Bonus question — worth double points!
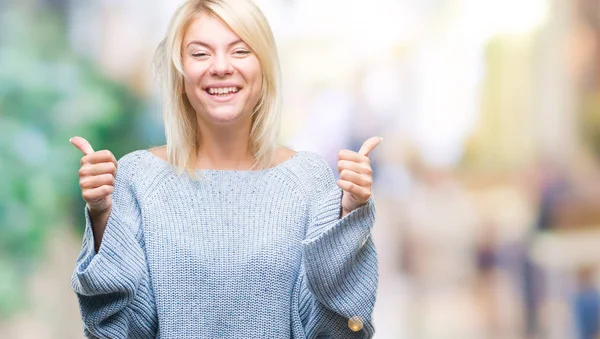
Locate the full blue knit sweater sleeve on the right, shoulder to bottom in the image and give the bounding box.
[296,158,378,338]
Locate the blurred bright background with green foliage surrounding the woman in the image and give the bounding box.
[0,0,600,339]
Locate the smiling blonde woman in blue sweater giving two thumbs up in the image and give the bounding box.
[70,0,381,338]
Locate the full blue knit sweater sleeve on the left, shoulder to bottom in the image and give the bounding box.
[71,155,158,338]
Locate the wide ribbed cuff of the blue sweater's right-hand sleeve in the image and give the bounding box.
[302,190,378,337]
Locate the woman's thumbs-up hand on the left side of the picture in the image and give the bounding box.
[69,137,117,213]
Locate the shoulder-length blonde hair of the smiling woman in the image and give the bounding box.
[154,0,281,177]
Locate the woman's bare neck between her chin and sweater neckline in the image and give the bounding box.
[198,119,254,170]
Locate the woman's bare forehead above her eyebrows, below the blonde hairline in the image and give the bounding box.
[183,13,240,45]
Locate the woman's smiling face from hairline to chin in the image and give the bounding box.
[182,14,262,125]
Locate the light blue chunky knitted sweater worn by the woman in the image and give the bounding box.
[71,150,378,339]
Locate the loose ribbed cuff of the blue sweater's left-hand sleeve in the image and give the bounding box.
[72,206,145,295]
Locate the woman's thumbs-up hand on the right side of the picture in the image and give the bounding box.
[337,137,382,217]
